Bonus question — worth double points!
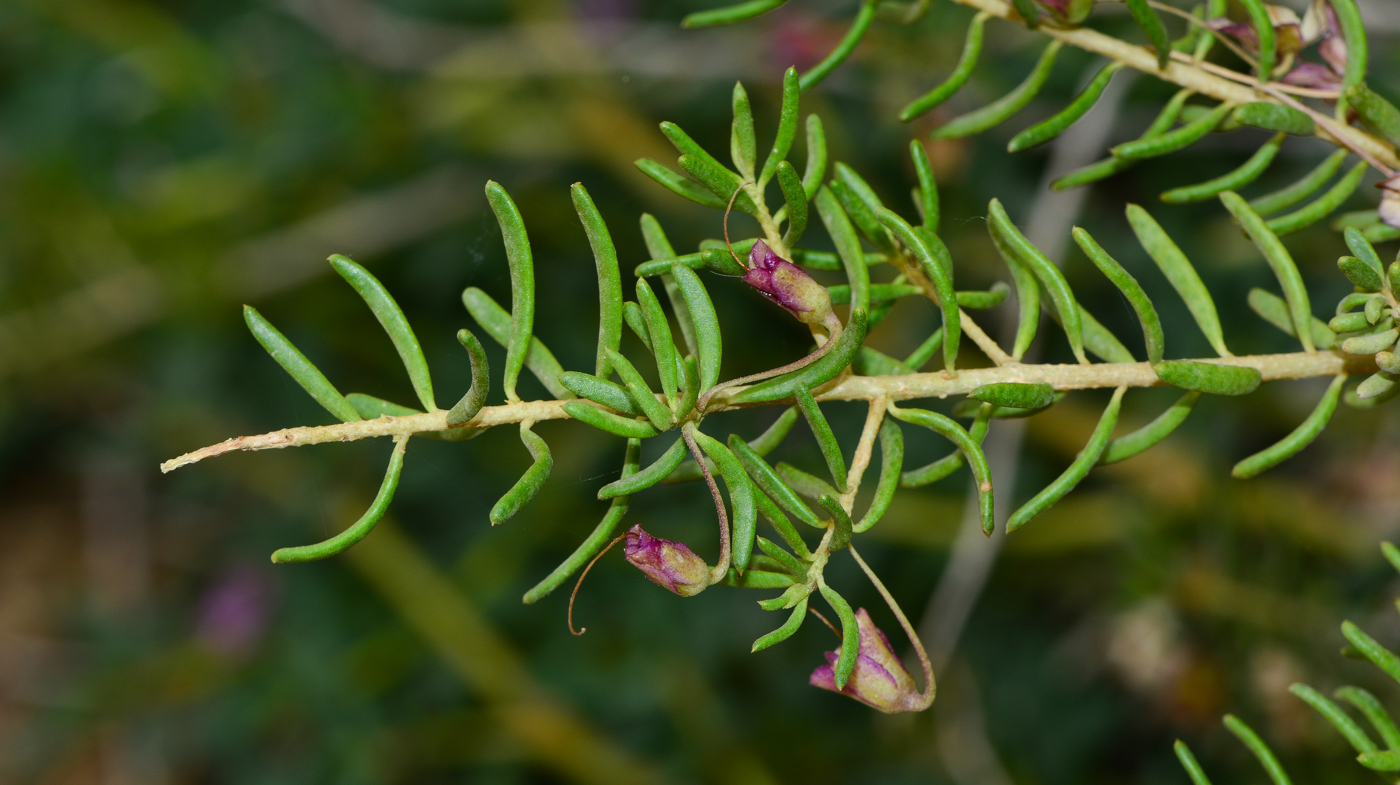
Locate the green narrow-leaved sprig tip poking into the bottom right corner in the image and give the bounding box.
[1176,543,1400,785]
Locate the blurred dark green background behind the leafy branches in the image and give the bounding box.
[8,0,1400,785]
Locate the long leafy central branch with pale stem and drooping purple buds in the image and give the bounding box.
[162,79,1400,711]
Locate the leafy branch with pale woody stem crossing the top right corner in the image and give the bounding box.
[687,0,1400,242]
